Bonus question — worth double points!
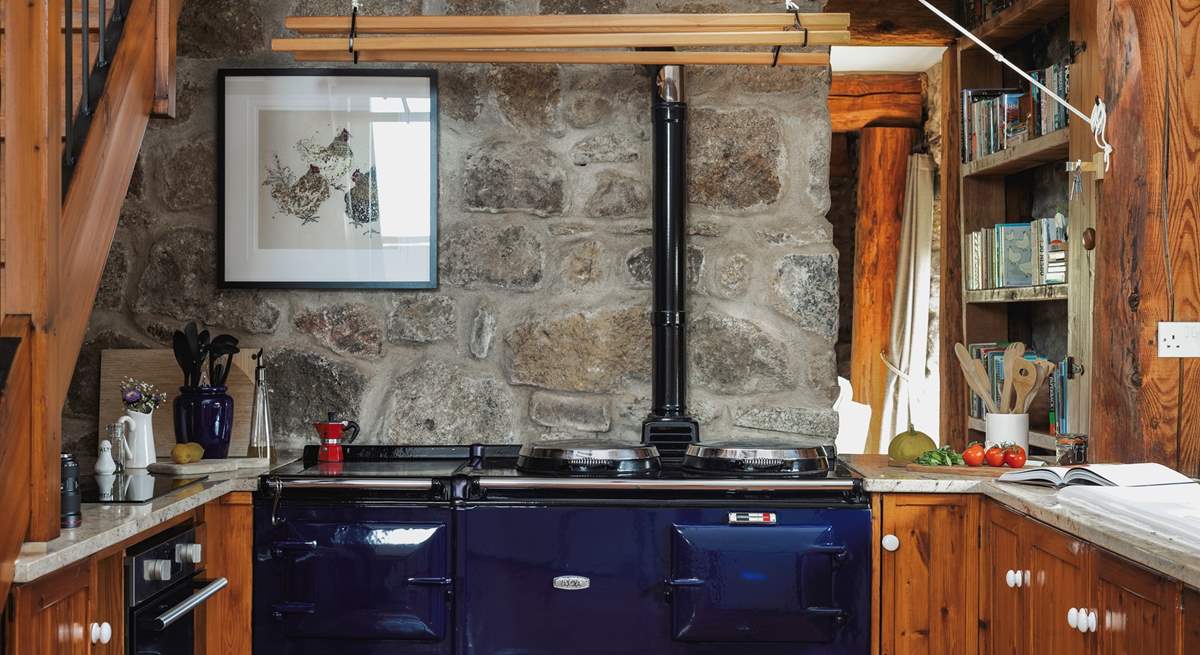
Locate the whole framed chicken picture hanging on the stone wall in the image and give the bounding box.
[217,68,438,289]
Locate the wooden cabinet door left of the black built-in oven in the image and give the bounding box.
[7,560,92,655]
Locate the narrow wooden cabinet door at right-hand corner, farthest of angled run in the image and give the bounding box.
[979,500,1028,655]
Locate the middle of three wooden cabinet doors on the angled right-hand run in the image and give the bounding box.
[1019,519,1092,655]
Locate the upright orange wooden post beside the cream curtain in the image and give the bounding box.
[851,127,917,452]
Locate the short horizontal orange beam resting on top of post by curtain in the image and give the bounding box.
[829,73,925,132]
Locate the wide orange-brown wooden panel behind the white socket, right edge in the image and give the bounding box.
[1091,0,1200,474]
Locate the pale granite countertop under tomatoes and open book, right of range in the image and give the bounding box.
[842,455,1200,589]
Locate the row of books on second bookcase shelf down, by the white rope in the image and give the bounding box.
[961,64,1070,163]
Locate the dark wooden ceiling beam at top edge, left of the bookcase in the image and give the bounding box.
[826,0,958,46]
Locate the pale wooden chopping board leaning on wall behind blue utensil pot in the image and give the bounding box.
[97,348,258,457]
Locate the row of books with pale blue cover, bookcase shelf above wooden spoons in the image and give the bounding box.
[966,214,1067,290]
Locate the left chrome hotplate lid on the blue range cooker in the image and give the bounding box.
[517,439,662,476]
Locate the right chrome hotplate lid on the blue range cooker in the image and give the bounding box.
[683,439,835,475]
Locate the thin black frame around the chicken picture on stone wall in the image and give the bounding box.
[216,68,440,290]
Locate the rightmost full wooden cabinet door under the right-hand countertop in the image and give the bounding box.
[1093,552,1180,655]
